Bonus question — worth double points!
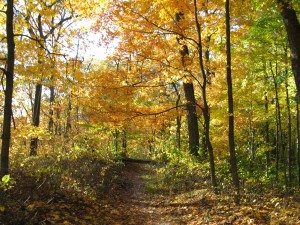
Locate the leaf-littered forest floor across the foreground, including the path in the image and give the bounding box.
[0,159,300,225]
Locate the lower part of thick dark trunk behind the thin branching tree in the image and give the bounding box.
[183,83,200,156]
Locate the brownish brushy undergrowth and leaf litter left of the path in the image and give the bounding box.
[0,150,122,225]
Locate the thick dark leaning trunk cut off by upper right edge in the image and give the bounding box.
[276,0,300,97]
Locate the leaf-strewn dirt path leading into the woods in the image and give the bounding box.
[101,162,199,225]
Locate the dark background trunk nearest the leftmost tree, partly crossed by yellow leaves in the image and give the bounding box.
[30,84,42,156]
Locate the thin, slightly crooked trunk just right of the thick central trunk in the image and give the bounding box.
[194,0,217,190]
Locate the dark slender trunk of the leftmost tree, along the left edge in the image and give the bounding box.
[0,0,15,177]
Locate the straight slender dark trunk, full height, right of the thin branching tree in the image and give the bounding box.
[225,0,240,203]
